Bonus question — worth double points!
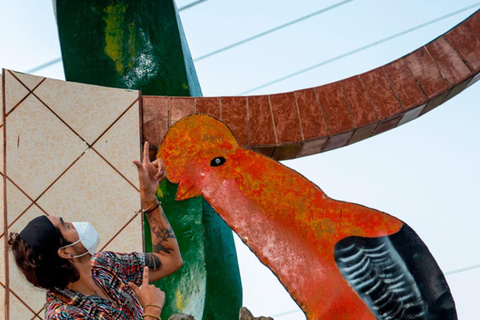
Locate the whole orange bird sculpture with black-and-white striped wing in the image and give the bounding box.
[158,115,456,320]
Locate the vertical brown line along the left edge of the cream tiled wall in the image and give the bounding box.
[2,69,10,320]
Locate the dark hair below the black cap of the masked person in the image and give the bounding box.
[8,230,80,290]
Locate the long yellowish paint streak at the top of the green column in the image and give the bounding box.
[103,3,126,75]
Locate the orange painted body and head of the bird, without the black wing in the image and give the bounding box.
[158,115,403,320]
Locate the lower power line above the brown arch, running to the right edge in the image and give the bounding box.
[239,2,480,95]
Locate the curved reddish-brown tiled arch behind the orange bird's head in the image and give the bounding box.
[143,10,480,160]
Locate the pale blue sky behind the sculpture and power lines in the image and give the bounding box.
[0,0,480,320]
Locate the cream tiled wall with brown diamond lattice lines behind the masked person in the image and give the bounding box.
[0,70,143,320]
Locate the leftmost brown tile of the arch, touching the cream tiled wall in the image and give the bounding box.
[142,96,168,146]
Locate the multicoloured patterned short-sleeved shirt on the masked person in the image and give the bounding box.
[45,251,145,320]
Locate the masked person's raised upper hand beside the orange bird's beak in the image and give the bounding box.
[133,142,167,202]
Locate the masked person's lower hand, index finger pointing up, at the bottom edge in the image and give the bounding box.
[128,267,165,315]
